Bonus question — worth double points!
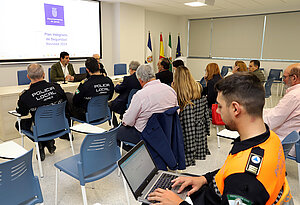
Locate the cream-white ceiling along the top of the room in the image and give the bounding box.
[102,0,300,18]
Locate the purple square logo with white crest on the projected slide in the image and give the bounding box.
[44,4,65,26]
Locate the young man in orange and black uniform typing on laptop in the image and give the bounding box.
[148,72,292,205]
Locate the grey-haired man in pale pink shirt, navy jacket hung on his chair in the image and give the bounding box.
[117,65,178,149]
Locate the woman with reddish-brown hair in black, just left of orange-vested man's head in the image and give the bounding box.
[204,63,222,109]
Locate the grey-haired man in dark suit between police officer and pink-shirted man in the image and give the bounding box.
[109,61,142,126]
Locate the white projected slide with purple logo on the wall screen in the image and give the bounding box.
[0,0,101,60]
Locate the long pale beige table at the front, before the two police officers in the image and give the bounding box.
[0,75,124,141]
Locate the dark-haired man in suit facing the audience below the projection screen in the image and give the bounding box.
[50,51,75,82]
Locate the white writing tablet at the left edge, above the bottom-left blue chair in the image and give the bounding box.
[0,141,27,162]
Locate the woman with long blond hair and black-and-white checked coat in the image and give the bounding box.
[172,66,210,167]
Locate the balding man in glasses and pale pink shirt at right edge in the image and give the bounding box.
[263,63,300,156]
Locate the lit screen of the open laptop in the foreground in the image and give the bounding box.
[119,144,156,192]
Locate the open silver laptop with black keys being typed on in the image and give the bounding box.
[118,141,188,204]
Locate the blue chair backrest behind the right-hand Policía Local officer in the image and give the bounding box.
[86,95,111,124]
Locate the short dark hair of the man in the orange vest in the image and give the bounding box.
[215,72,265,117]
